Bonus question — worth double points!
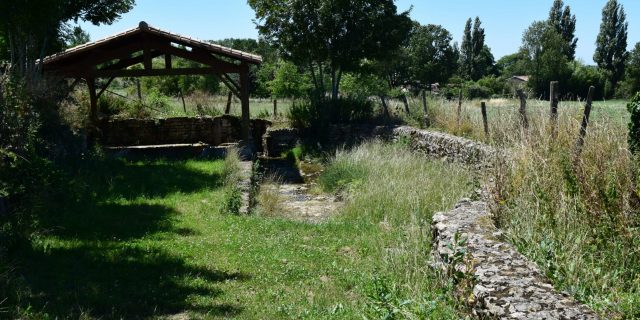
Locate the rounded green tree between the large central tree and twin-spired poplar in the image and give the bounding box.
[406,23,457,85]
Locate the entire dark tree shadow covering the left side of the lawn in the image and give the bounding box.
[0,160,249,319]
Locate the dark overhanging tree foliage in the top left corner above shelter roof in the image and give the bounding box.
[0,0,134,76]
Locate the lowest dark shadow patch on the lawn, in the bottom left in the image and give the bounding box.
[19,244,248,319]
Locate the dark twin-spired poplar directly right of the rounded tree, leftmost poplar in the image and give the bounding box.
[459,17,494,81]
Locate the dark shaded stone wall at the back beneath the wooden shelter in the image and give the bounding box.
[99,115,271,151]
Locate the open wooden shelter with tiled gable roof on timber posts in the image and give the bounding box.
[43,21,262,141]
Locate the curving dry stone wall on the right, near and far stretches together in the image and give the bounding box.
[393,127,598,319]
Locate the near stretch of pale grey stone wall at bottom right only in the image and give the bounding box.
[432,200,598,319]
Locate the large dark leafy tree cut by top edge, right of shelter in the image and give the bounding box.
[249,0,411,100]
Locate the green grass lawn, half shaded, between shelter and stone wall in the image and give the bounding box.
[7,143,470,319]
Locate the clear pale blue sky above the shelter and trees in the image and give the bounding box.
[82,0,640,64]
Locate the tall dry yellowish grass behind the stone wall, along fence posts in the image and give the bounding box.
[402,96,640,319]
